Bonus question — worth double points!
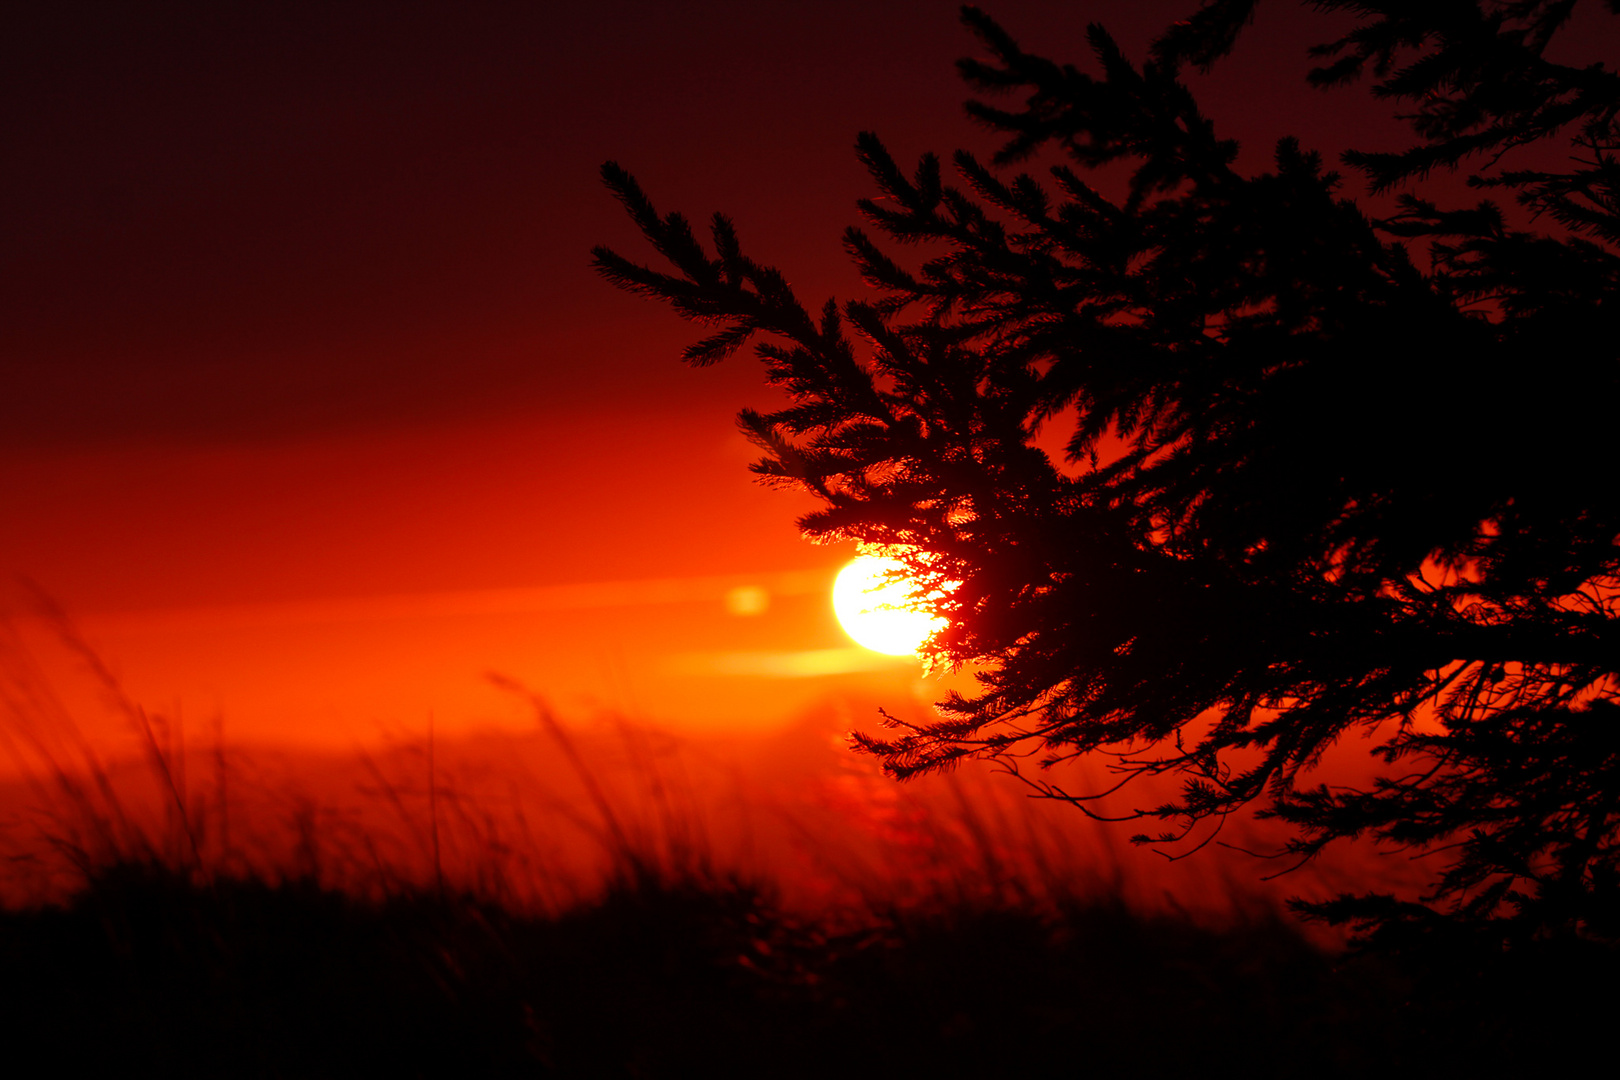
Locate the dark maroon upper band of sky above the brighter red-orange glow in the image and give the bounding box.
[0,2,1023,445]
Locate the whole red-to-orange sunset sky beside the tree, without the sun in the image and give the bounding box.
[9,0,1607,751]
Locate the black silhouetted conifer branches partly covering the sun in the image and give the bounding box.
[596,0,1620,939]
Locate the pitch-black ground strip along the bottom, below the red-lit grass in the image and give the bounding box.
[0,865,1620,1077]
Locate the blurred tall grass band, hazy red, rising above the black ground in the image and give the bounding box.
[0,602,1321,923]
